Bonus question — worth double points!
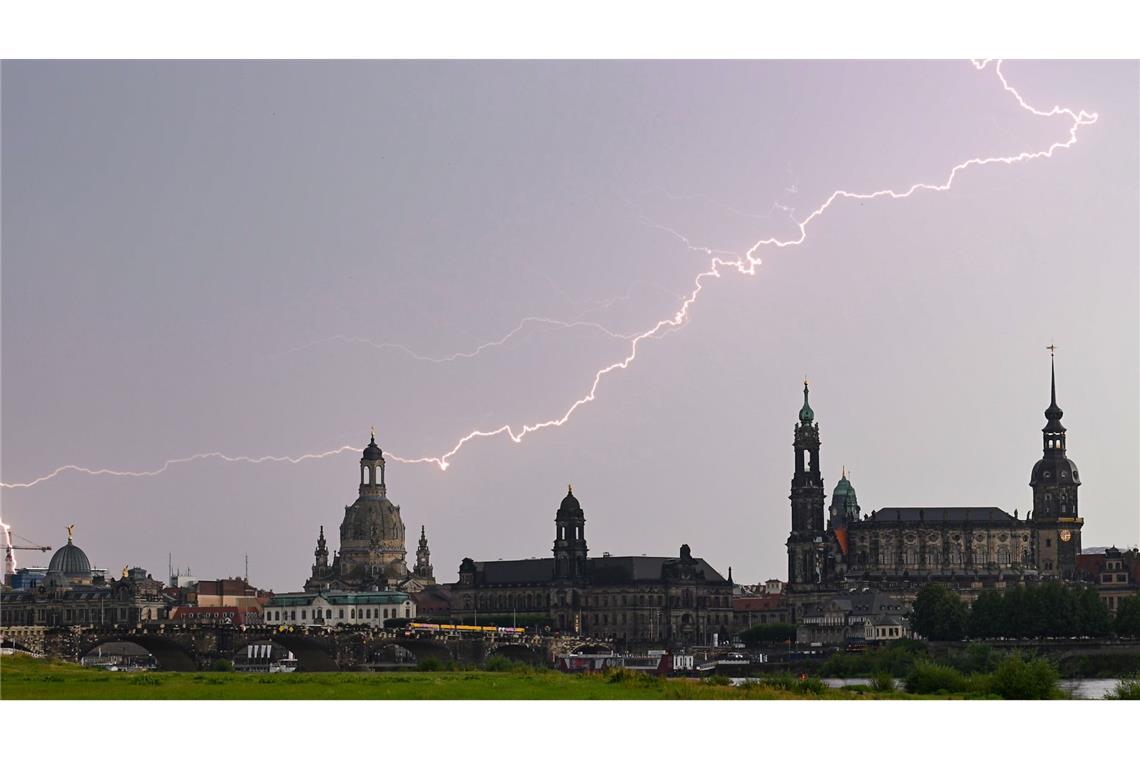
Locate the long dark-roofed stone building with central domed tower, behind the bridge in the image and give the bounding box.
[451,489,733,647]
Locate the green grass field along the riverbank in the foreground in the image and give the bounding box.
[0,655,909,700]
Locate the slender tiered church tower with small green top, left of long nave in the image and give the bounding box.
[788,379,824,591]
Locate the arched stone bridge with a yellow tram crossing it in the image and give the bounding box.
[0,623,601,672]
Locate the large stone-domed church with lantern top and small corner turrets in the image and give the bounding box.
[304,433,435,593]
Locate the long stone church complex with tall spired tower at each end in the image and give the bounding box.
[787,359,1084,594]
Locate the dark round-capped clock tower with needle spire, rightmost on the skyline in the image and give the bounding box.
[1029,346,1084,579]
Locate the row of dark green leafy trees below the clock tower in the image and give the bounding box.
[911,581,1140,641]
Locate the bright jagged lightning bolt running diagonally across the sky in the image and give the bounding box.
[0,59,1098,488]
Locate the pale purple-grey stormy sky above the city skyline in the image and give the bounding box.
[0,60,1140,591]
